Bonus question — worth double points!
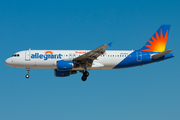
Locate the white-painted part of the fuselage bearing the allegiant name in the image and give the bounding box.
[5,50,133,70]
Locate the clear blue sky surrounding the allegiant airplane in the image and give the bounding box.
[0,0,180,120]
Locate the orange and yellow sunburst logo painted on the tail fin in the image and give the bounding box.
[142,29,168,52]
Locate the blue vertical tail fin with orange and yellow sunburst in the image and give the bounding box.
[140,25,170,52]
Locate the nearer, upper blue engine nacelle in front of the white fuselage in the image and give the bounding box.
[57,60,73,71]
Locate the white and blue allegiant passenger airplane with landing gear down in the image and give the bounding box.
[5,25,174,81]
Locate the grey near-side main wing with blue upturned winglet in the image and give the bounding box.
[73,42,112,67]
